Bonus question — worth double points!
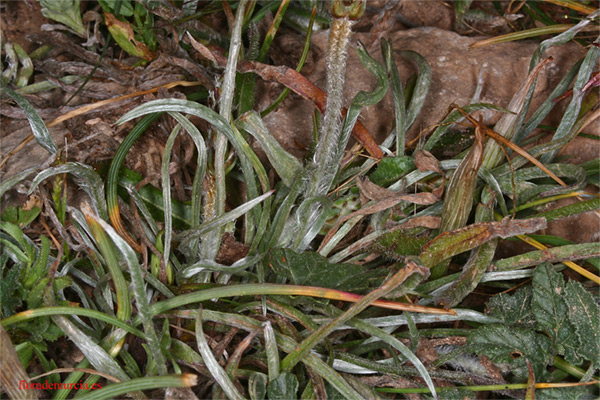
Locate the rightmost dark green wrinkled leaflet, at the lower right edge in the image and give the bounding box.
[565,281,600,368]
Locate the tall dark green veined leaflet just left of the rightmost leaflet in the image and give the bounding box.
[532,264,583,365]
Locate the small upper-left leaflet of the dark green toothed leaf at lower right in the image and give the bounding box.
[487,286,536,329]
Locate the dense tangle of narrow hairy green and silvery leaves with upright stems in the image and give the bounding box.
[0,1,600,399]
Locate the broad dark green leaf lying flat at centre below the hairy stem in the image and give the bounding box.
[269,249,387,292]
